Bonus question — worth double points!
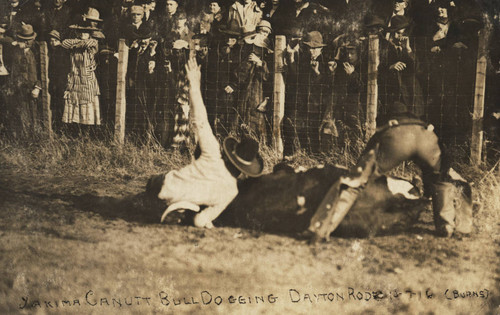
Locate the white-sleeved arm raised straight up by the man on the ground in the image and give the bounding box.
[186,58,220,156]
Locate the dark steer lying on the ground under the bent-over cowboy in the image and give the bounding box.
[217,166,425,236]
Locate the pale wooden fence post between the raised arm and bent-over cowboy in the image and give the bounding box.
[273,35,286,157]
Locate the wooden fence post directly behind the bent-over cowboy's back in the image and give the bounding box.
[366,35,380,140]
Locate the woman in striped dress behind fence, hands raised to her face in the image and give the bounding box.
[62,25,101,125]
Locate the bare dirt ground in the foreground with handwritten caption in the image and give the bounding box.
[0,166,500,314]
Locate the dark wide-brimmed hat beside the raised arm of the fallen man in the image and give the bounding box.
[223,137,264,177]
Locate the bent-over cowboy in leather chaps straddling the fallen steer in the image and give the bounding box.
[308,102,472,241]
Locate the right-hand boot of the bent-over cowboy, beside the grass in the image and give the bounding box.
[432,182,455,237]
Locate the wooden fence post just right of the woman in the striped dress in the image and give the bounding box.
[115,39,128,144]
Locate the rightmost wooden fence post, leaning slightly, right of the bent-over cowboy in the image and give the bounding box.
[470,30,487,165]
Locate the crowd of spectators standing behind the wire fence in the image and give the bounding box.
[0,0,492,154]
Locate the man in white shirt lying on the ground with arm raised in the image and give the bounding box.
[146,58,264,228]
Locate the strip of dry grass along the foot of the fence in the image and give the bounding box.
[0,130,500,223]
